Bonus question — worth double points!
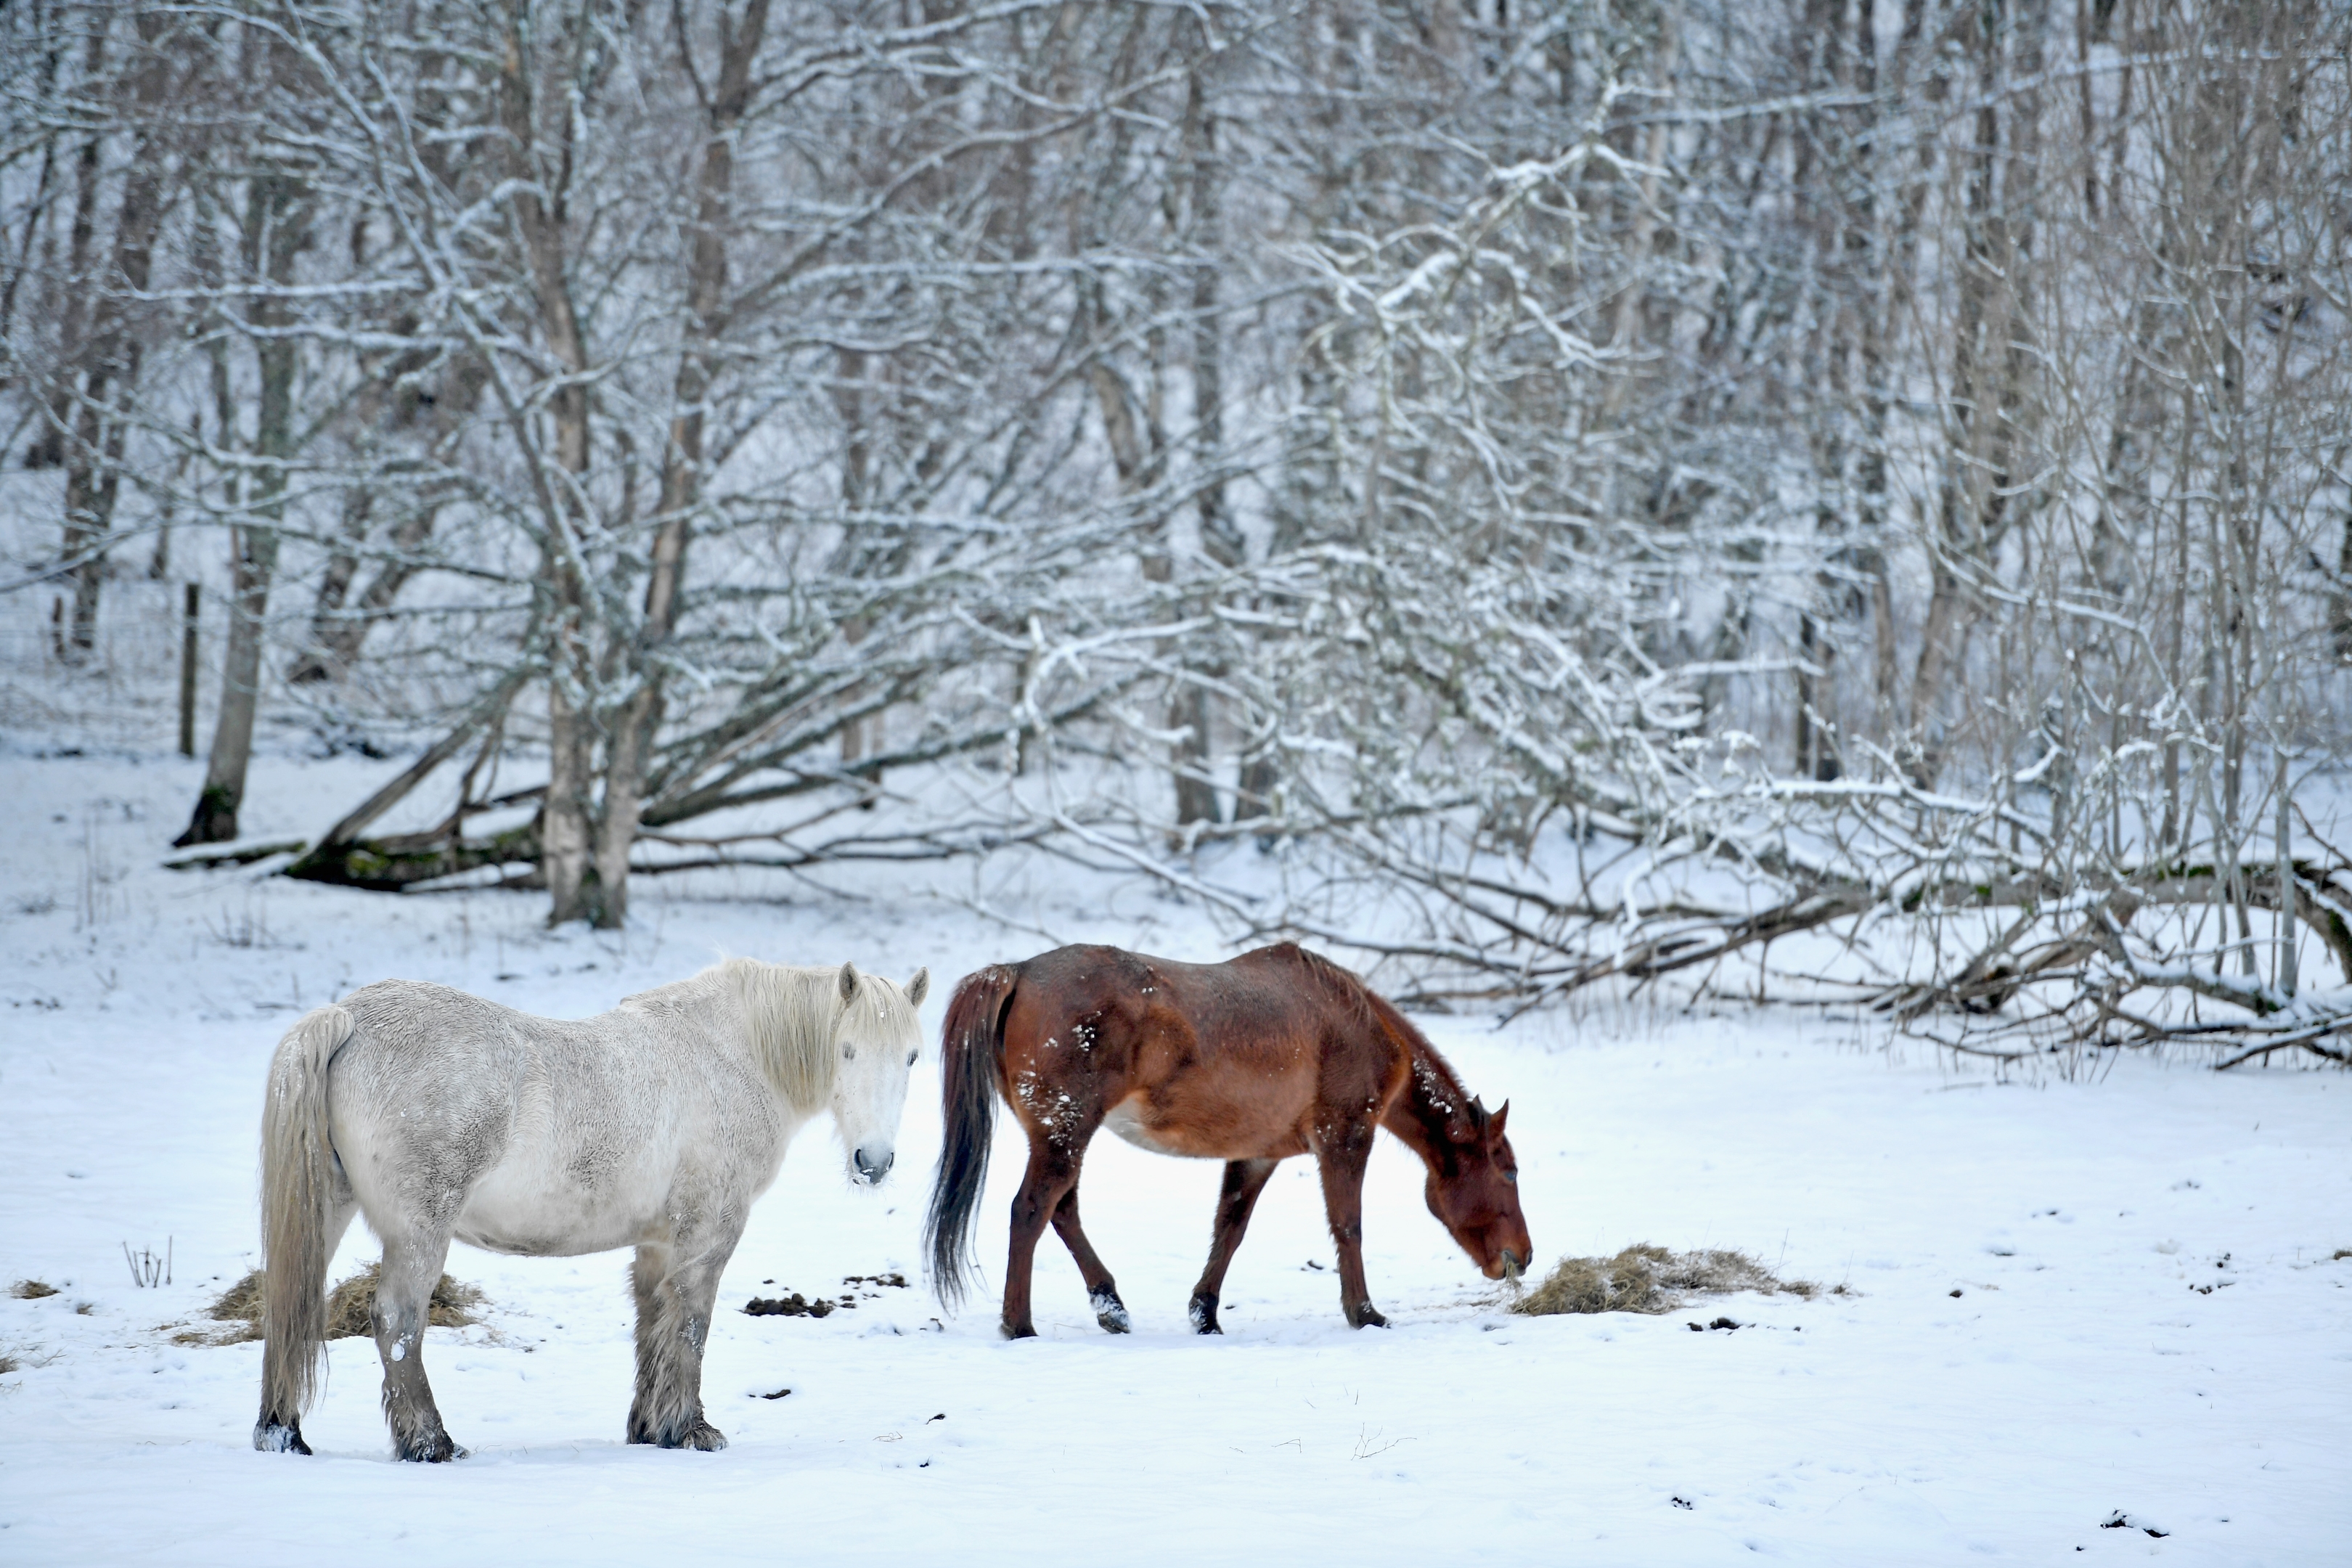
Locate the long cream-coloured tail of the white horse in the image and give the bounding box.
[254,1006,357,1448]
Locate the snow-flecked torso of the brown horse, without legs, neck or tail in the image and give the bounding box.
[1000,945,1409,1159]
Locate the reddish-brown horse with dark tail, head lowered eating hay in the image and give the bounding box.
[924,943,1533,1340]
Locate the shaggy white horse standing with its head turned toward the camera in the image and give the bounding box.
[254,959,931,1460]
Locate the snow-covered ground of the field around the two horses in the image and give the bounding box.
[0,747,2352,1568]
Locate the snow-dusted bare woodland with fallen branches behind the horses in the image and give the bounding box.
[0,0,2352,1063]
